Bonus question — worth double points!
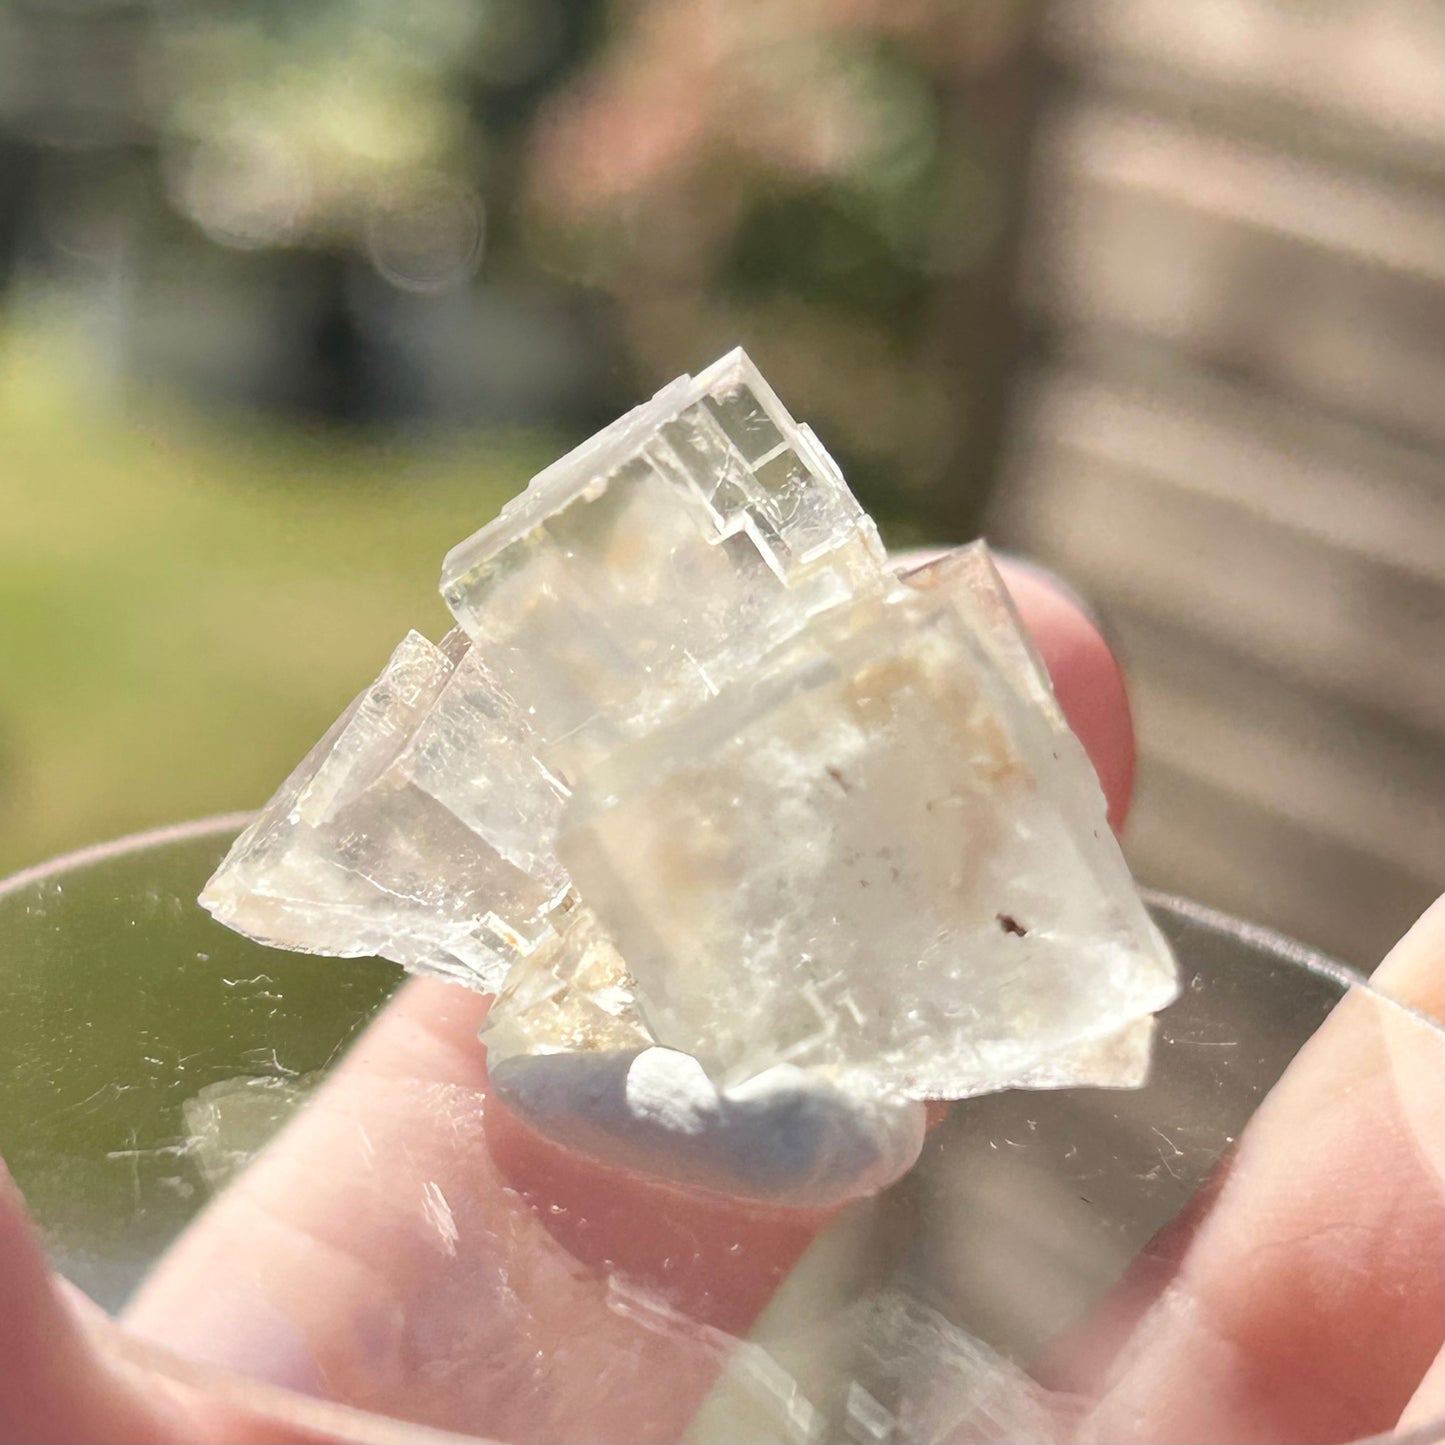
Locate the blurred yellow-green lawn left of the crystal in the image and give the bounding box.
[0,322,562,876]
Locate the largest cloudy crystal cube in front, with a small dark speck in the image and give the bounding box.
[559,555,1175,1098]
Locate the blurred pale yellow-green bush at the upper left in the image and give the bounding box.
[159,0,531,275]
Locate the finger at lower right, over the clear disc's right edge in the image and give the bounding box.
[1051,903,1445,1441]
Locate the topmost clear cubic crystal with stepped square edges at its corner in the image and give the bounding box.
[442,351,887,785]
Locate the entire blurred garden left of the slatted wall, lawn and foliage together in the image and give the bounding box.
[0,0,1033,870]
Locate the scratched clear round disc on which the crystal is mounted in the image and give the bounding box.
[0,816,1442,1442]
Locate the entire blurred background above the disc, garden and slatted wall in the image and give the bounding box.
[0,0,1445,964]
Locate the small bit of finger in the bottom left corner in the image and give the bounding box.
[0,1165,195,1445]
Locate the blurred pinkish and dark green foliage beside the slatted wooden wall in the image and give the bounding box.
[529,0,1035,533]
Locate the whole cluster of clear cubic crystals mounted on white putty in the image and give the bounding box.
[202,351,1176,1117]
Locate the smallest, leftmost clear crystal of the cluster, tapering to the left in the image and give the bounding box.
[201,633,568,987]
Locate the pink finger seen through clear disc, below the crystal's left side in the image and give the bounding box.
[126,981,824,1439]
